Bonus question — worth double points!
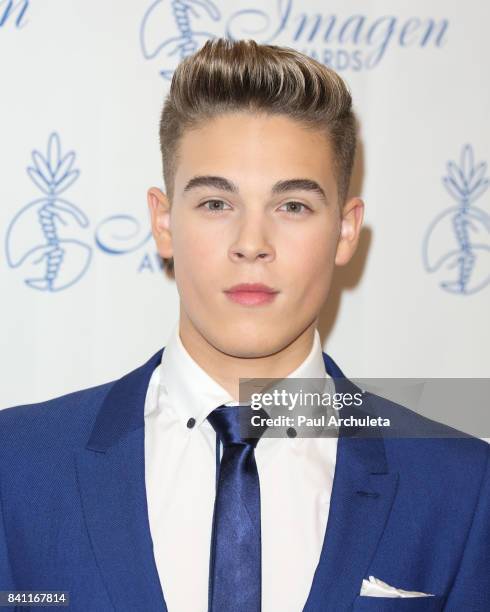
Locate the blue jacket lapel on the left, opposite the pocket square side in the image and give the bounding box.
[75,349,167,612]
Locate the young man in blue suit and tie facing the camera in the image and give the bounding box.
[0,39,490,612]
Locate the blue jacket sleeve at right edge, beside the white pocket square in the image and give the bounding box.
[444,444,490,612]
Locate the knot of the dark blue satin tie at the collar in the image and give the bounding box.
[208,405,268,448]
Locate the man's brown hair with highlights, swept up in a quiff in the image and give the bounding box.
[160,38,356,270]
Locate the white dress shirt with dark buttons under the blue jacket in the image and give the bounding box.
[145,323,337,612]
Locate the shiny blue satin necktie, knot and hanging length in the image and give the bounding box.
[208,406,266,612]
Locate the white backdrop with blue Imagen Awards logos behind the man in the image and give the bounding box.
[0,0,490,408]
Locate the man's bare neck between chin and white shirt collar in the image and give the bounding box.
[179,308,318,402]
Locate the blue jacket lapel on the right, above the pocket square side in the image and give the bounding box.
[304,353,398,612]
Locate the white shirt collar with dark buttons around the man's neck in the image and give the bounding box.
[154,322,330,426]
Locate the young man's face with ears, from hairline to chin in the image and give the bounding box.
[149,113,362,358]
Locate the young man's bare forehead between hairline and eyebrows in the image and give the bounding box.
[175,112,335,193]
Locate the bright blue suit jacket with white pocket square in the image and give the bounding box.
[0,349,490,612]
